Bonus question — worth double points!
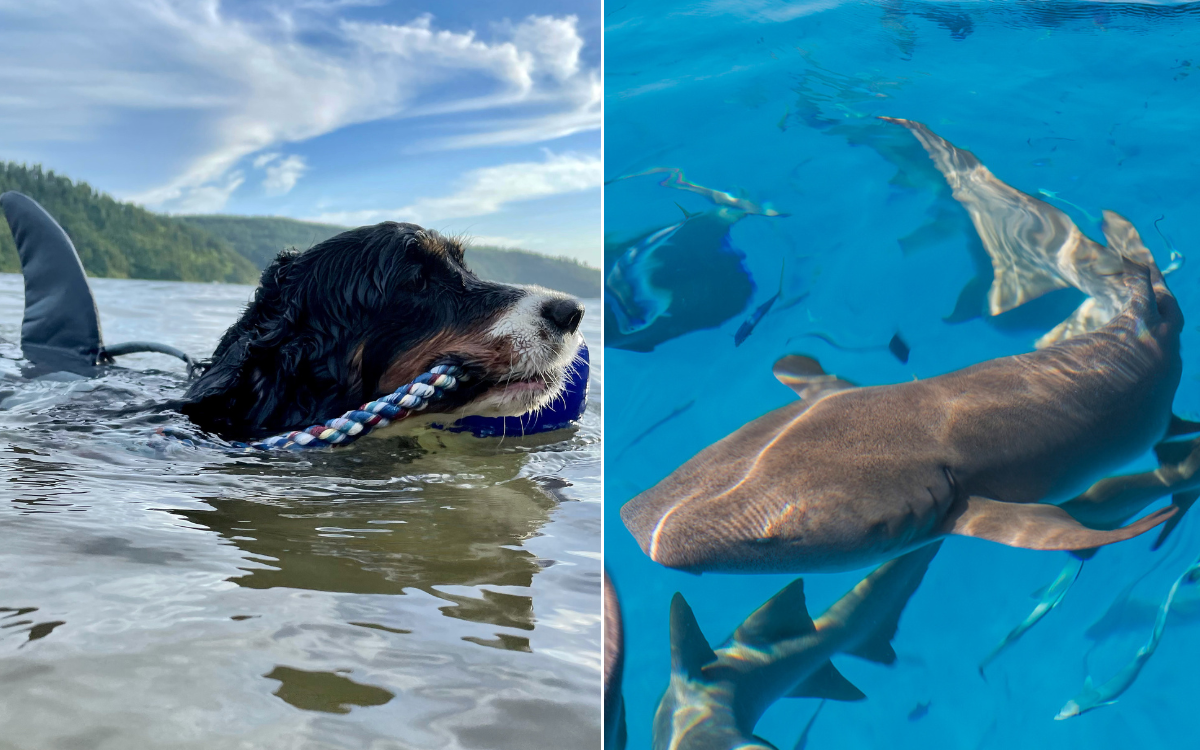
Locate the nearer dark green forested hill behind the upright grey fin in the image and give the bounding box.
[0,162,258,283]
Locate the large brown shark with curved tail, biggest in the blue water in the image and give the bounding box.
[620,118,1200,572]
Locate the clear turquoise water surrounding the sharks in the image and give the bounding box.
[605,0,1200,749]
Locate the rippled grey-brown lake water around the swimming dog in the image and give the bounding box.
[0,275,601,749]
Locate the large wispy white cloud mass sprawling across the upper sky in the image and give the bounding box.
[0,0,600,211]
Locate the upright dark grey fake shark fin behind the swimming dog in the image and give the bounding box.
[0,192,102,374]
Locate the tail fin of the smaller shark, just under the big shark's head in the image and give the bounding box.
[818,541,942,664]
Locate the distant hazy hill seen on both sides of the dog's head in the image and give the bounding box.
[180,216,600,298]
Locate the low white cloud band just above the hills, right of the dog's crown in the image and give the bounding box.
[313,154,602,226]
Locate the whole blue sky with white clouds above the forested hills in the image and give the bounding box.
[0,0,601,265]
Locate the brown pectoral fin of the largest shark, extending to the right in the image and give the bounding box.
[943,496,1177,550]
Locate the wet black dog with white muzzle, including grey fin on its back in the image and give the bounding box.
[0,193,583,438]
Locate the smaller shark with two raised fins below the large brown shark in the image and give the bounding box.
[652,544,940,750]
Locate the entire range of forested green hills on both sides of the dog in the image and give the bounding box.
[0,162,600,298]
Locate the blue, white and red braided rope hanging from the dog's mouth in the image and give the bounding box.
[157,365,464,454]
